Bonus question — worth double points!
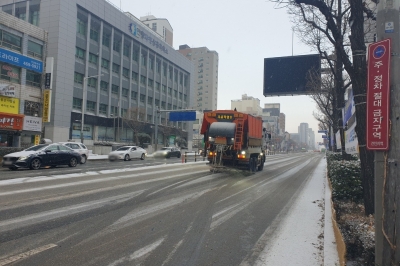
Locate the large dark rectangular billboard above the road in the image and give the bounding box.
[263,54,321,97]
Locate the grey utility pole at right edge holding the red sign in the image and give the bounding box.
[375,0,400,265]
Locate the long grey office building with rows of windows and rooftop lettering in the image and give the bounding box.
[0,0,193,145]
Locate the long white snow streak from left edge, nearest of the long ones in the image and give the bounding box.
[0,190,144,232]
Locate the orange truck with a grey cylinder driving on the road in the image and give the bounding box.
[200,110,267,172]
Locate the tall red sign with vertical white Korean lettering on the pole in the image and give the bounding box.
[367,39,391,151]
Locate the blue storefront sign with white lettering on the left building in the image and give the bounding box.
[0,48,43,73]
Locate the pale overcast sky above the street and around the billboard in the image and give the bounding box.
[109,0,322,145]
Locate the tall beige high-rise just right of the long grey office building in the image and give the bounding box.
[178,44,218,112]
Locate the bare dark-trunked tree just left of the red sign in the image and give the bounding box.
[278,0,374,215]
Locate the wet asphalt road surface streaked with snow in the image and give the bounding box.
[0,153,322,266]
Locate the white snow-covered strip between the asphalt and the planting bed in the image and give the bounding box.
[255,159,339,266]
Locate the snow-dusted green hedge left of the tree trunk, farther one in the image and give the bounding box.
[327,153,363,202]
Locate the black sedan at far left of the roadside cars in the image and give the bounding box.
[2,143,81,170]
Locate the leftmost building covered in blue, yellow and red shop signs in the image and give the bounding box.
[0,9,48,147]
